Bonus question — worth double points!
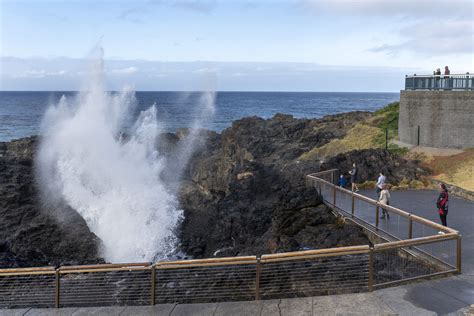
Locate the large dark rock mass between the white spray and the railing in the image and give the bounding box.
[180,112,382,257]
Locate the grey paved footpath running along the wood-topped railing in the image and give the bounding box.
[0,190,474,316]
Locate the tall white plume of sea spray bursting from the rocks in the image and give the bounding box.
[37,48,214,262]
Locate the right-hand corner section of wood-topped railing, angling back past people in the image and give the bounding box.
[307,169,461,288]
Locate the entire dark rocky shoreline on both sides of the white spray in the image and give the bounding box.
[0,112,427,267]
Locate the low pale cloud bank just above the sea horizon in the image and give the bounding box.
[0,57,416,92]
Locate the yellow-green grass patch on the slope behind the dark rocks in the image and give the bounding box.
[299,124,384,160]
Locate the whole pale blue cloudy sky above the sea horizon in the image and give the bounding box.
[0,0,474,92]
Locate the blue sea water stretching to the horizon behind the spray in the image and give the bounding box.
[0,91,400,141]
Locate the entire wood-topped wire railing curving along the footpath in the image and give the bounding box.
[0,170,461,308]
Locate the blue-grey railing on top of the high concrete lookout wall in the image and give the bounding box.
[405,74,474,90]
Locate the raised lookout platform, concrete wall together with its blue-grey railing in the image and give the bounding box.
[398,74,474,149]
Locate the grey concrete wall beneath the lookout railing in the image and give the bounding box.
[398,90,474,148]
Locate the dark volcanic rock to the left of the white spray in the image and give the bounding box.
[0,137,103,267]
